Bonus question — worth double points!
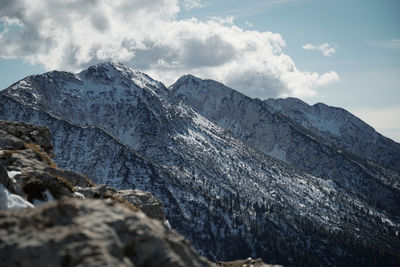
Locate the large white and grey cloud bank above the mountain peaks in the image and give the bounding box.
[0,0,339,98]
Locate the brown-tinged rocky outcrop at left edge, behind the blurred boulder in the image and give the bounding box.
[0,121,88,203]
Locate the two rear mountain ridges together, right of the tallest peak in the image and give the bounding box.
[170,75,400,217]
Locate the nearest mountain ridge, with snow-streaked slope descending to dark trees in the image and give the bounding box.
[0,62,400,265]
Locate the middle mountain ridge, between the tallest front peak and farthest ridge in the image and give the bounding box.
[170,76,400,216]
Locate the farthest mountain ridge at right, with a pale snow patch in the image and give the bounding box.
[264,98,400,172]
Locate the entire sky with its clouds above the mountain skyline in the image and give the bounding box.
[0,0,400,142]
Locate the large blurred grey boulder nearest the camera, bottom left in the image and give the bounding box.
[0,199,213,267]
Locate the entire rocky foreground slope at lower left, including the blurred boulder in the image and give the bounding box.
[0,121,214,266]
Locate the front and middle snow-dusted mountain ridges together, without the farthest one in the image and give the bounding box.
[0,63,400,265]
